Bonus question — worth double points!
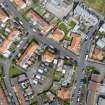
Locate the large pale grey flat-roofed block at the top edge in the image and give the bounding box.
[42,0,73,19]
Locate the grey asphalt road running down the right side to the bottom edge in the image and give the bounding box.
[72,25,99,105]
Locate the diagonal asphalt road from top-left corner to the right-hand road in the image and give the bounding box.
[0,0,78,60]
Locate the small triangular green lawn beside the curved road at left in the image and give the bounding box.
[9,66,24,78]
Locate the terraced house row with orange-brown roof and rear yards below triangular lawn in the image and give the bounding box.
[13,74,34,105]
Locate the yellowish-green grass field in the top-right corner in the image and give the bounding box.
[84,0,105,16]
